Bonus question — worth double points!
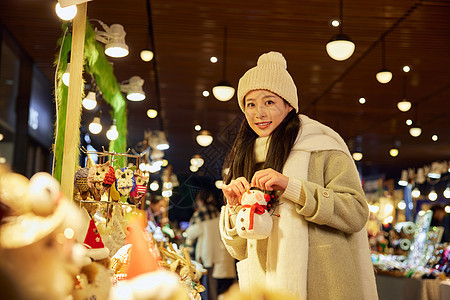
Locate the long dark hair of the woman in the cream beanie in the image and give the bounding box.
[223,109,301,184]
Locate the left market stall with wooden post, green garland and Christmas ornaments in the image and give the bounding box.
[0,1,204,299]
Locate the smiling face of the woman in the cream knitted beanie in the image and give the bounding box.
[244,90,292,137]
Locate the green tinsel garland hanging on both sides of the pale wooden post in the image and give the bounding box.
[53,22,127,181]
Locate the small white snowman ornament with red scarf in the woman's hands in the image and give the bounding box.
[236,190,272,240]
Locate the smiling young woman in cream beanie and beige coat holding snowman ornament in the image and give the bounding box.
[220,52,378,299]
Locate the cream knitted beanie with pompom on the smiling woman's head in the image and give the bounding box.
[237,51,298,112]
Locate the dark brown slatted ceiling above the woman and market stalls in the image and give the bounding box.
[0,0,450,182]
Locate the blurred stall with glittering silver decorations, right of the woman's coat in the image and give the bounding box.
[366,163,450,299]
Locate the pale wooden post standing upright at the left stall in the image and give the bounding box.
[61,2,87,199]
